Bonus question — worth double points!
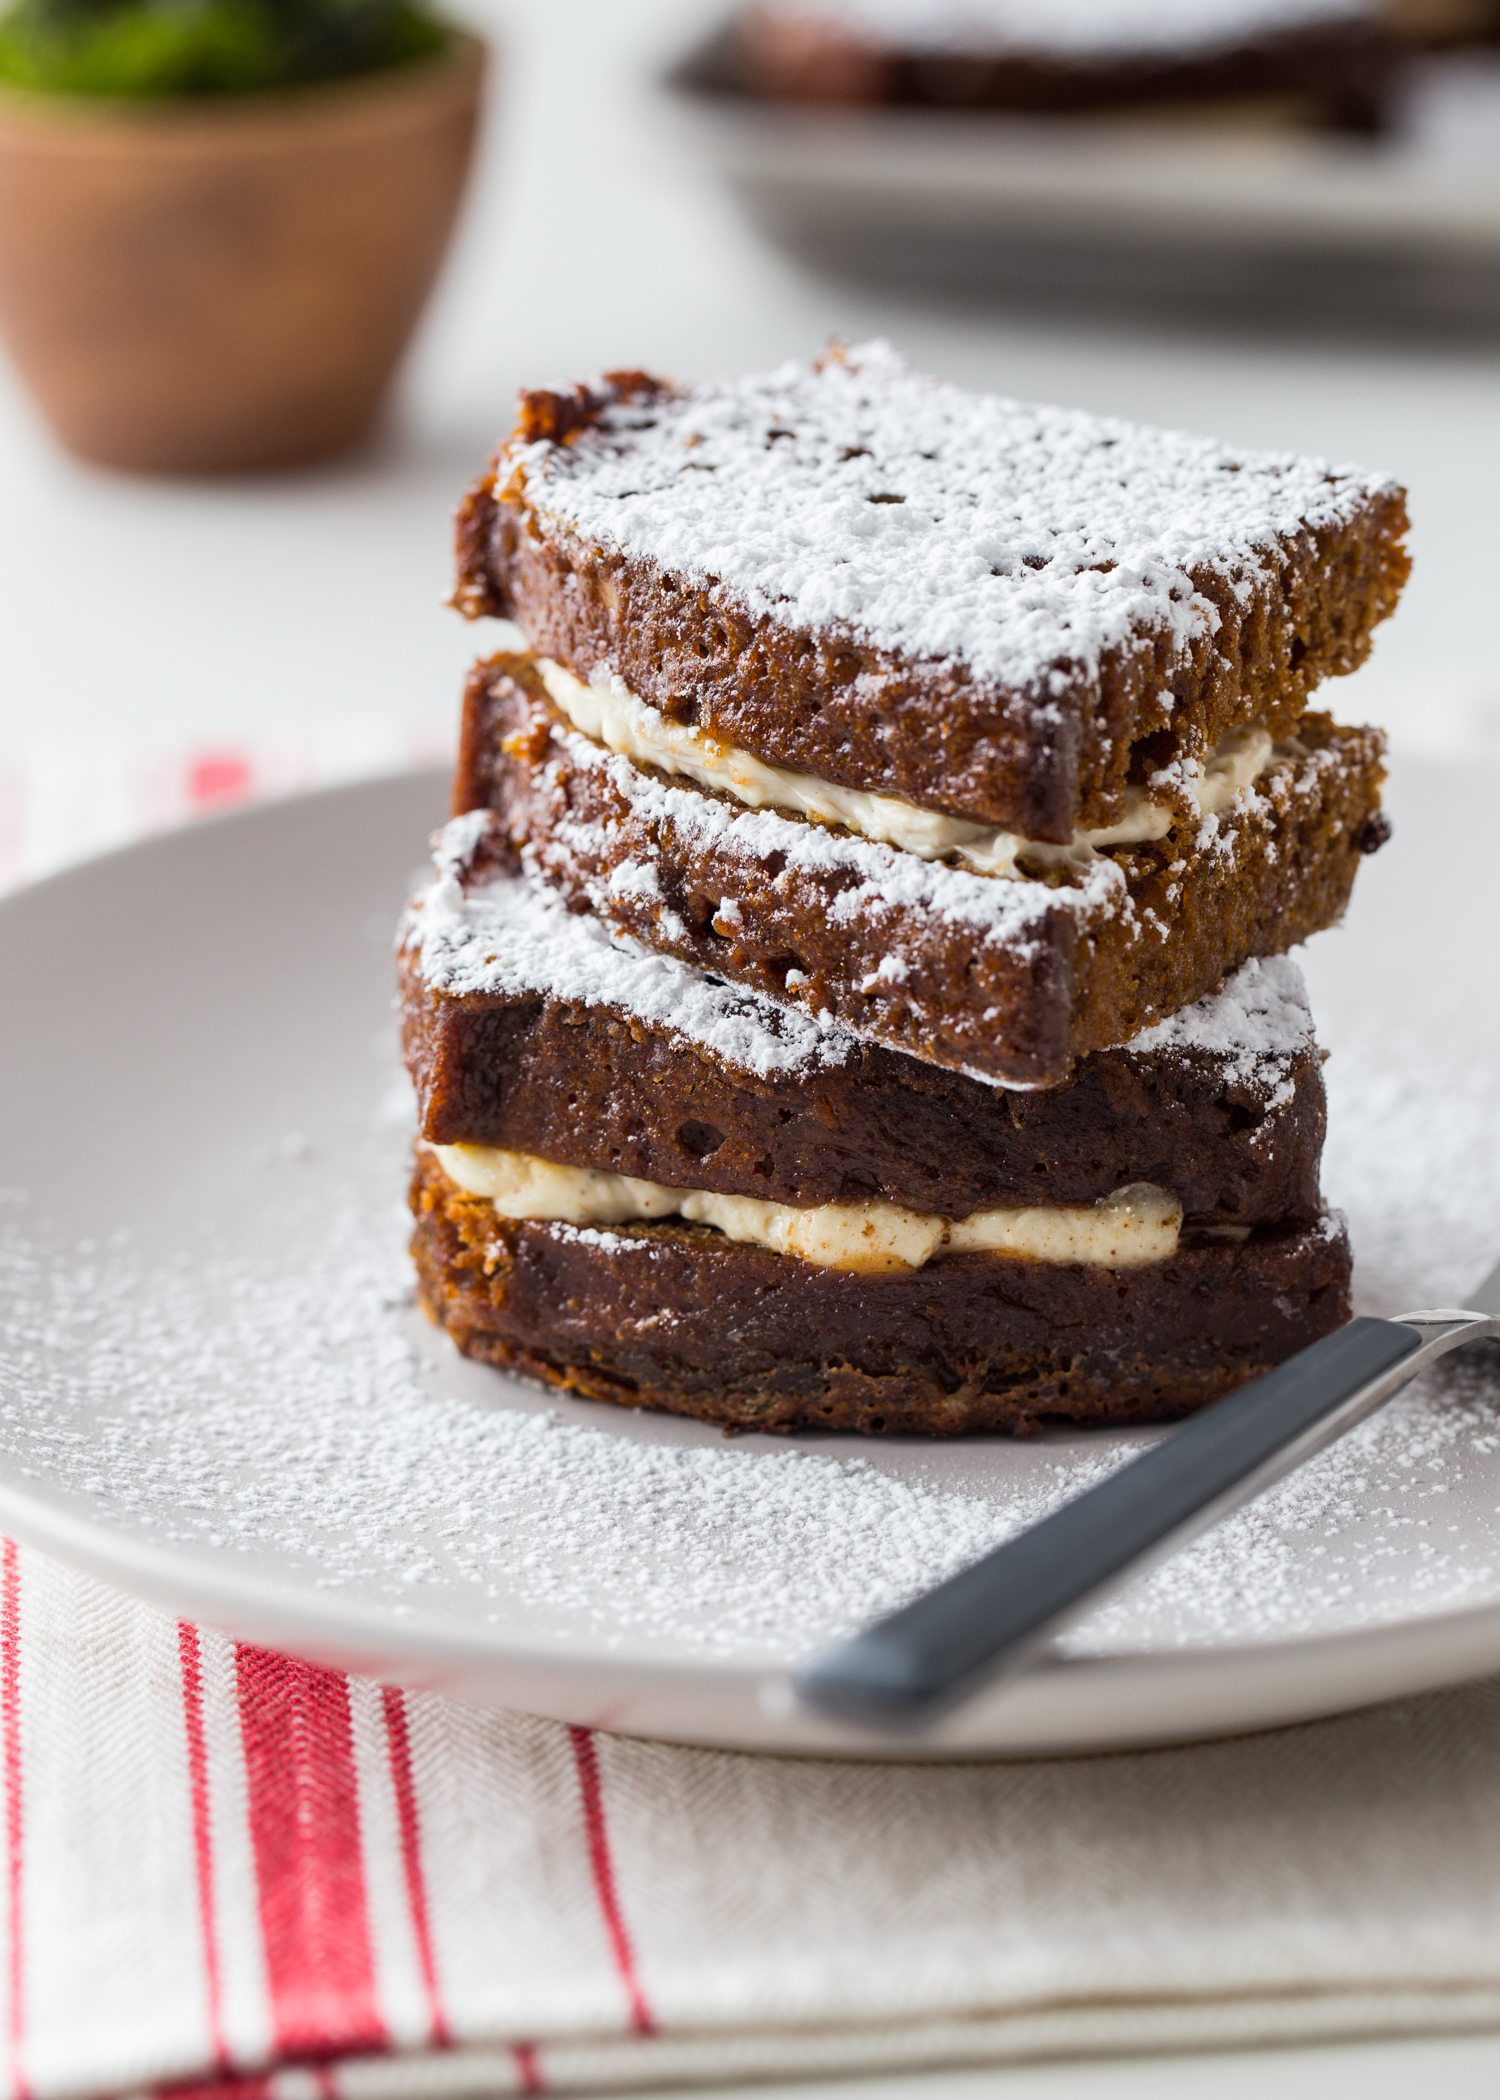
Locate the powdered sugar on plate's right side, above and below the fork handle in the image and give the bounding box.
[1074,1042,1500,1646]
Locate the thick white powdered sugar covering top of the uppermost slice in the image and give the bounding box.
[514,342,1387,699]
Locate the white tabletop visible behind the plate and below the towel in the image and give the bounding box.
[0,0,1500,2100]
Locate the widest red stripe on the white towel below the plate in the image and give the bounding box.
[235,1646,387,2058]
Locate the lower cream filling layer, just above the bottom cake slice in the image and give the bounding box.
[431,1145,1183,1273]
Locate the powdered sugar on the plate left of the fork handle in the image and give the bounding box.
[0,1205,1075,1655]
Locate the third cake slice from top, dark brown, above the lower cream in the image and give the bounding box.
[401,878,1324,1226]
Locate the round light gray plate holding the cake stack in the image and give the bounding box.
[0,755,1500,1756]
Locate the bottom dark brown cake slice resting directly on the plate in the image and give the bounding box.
[412,1155,1349,1436]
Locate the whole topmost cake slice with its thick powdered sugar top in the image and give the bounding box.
[456,344,1410,842]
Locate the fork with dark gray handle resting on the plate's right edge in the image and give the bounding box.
[792,1264,1500,1730]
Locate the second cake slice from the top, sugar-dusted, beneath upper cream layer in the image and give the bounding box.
[456,655,1382,1086]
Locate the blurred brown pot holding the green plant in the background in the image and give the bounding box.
[0,36,485,473]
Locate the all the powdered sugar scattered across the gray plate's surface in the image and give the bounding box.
[0,986,1500,1661]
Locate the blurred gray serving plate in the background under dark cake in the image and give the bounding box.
[664,38,1500,336]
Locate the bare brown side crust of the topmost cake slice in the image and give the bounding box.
[454,386,1410,844]
